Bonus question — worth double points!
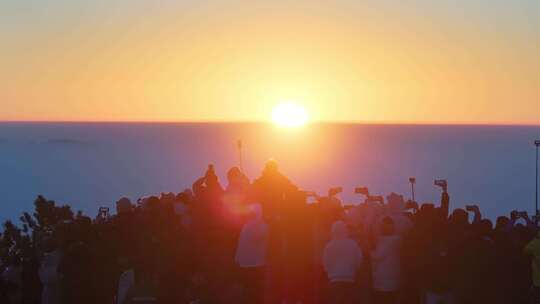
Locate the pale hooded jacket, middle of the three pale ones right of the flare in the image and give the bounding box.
[323,221,363,282]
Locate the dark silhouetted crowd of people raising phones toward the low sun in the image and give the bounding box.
[0,160,540,304]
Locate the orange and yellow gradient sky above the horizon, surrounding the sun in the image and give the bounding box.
[0,0,540,124]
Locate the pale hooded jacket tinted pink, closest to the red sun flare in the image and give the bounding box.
[235,204,268,267]
